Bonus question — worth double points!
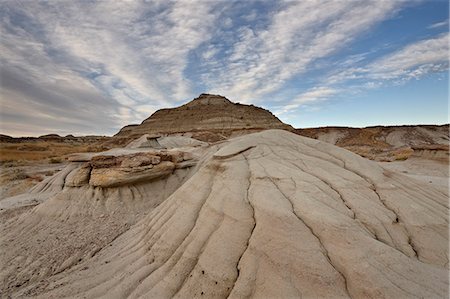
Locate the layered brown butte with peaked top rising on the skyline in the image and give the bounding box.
[113,94,293,144]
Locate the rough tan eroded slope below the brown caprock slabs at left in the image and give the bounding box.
[0,159,192,298]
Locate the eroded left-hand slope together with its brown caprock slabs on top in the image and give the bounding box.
[0,146,204,298]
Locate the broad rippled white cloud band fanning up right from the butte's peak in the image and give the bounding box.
[208,1,403,102]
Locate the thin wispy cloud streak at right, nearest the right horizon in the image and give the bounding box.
[278,33,449,114]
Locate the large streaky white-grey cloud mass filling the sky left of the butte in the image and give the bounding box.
[0,1,218,134]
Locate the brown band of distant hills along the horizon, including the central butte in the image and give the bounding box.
[0,94,450,161]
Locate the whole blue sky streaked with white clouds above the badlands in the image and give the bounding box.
[0,0,449,136]
